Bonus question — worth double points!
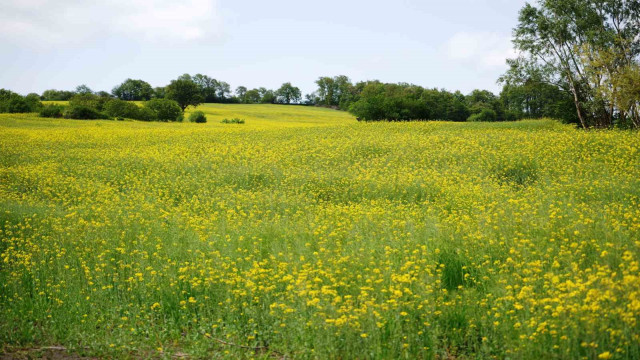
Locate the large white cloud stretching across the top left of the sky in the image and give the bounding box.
[0,0,221,44]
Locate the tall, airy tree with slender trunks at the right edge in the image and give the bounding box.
[503,0,640,128]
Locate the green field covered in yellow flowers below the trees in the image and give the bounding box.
[0,105,640,359]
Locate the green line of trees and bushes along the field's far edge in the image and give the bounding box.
[0,0,640,128]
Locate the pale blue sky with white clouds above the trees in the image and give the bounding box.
[0,0,525,94]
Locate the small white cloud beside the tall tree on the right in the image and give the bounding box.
[446,32,516,68]
